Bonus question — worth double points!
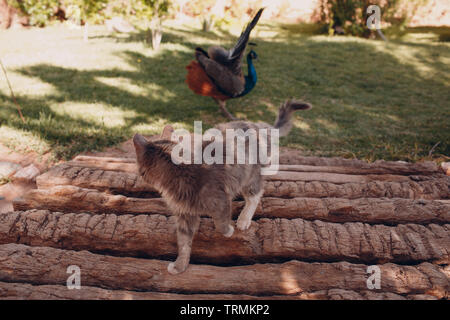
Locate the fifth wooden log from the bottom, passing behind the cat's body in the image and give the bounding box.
[36,164,450,199]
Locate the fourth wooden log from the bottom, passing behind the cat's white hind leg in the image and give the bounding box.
[13,186,450,225]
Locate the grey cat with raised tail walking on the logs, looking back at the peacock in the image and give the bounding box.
[133,100,311,274]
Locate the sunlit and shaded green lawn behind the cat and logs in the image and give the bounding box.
[0,23,450,161]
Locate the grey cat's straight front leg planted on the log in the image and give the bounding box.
[167,215,200,274]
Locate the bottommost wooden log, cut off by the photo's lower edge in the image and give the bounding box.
[0,282,437,300]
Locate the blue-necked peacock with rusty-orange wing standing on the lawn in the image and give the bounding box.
[186,8,264,120]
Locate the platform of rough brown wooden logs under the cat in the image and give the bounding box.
[0,152,450,299]
